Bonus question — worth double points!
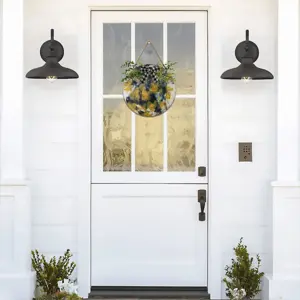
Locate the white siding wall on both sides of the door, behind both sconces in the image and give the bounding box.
[24,0,277,296]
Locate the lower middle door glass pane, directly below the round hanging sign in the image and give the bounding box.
[135,117,163,171]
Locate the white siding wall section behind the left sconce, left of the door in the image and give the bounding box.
[24,1,78,270]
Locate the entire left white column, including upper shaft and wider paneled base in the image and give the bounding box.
[0,0,35,300]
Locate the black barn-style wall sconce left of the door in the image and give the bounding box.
[26,29,79,82]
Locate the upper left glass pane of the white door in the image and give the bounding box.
[103,23,131,94]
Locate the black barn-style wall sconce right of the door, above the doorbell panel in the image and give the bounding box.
[221,30,274,81]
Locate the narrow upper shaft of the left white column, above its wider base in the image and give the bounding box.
[0,0,24,179]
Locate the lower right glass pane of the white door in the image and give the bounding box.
[168,99,195,172]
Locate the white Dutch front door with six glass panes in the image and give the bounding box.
[91,11,208,287]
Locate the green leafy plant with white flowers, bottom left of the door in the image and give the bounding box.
[31,249,82,300]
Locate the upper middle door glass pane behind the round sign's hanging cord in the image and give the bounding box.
[135,23,163,64]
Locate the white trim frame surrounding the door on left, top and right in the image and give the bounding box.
[77,0,222,298]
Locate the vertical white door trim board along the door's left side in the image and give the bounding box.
[74,9,91,298]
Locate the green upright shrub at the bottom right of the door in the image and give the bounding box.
[223,238,264,300]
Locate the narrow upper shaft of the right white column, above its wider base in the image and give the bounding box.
[277,0,300,181]
